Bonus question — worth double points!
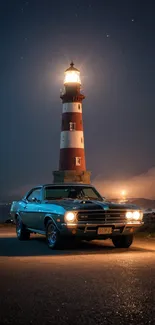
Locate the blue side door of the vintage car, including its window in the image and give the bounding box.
[22,188,42,229]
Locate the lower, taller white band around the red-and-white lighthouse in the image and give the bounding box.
[60,131,84,149]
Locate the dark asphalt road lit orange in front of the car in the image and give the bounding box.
[0,228,155,325]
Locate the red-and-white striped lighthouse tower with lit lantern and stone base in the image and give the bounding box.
[53,62,90,184]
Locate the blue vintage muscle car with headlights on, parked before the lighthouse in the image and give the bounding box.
[10,184,143,249]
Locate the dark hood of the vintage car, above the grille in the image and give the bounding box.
[47,199,140,211]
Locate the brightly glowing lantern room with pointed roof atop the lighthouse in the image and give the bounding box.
[64,62,81,85]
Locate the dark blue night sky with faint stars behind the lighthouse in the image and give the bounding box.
[0,0,155,196]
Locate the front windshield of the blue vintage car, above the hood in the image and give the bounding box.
[44,185,103,201]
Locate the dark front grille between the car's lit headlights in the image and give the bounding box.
[77,209,126,224]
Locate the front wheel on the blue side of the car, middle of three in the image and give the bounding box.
[46,221,61,249]
